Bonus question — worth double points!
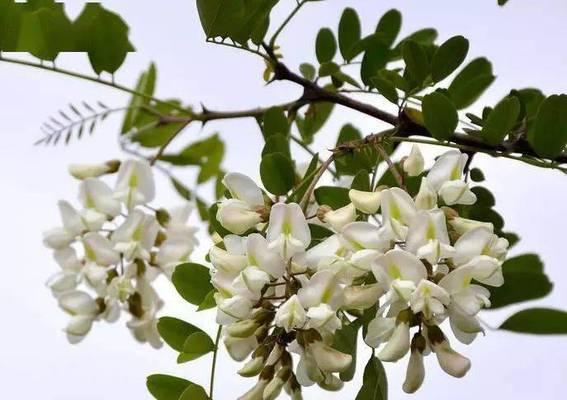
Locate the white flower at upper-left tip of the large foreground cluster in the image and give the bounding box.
[216,172,264,235]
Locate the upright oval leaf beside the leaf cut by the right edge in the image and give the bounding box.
[480,96,520,146]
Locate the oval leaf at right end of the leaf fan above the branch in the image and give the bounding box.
[448,58,495,110]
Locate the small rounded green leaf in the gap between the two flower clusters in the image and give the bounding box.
[171,263,213,306]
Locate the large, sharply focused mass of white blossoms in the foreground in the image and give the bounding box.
[209,147,508,400]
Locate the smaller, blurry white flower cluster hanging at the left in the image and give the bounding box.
[44,160,197,348]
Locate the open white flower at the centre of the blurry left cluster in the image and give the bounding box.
[111,209,159,260]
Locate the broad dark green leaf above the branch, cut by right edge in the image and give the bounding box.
[528,94,567,158]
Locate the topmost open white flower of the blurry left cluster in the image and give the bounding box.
[114,160,155,210]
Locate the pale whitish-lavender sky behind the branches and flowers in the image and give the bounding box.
[0,0,567,400]
